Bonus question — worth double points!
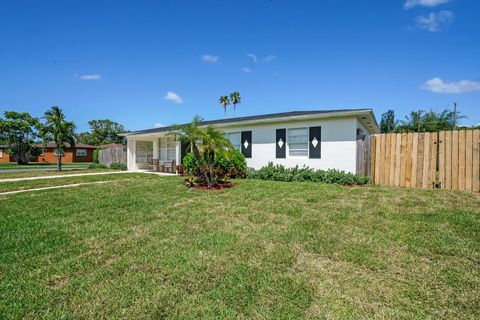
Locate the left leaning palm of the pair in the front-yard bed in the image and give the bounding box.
[168,115,213,187]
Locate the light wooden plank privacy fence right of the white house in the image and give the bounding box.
[372,129,480,192]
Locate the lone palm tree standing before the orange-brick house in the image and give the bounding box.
[41,106,75,171]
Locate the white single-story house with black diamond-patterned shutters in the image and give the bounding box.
[127,109,379,173]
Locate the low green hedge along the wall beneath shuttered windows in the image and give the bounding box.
[247,162,370,185]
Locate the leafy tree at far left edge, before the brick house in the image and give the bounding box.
[0,111,40,164]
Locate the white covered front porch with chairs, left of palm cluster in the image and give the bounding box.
[127,133,188,173]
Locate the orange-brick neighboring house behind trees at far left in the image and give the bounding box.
[0,143,97,163]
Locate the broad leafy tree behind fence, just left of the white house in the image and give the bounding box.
[78,119,125,146]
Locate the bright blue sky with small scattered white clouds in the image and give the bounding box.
[0,0,480,130]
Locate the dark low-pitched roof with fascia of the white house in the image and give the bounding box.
[122,109,379,136]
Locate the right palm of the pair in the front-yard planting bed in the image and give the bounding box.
[201,126,233,184]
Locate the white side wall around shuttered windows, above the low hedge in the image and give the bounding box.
[220,117,358,173]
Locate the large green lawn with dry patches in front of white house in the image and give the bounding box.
[0,174,480,319]
